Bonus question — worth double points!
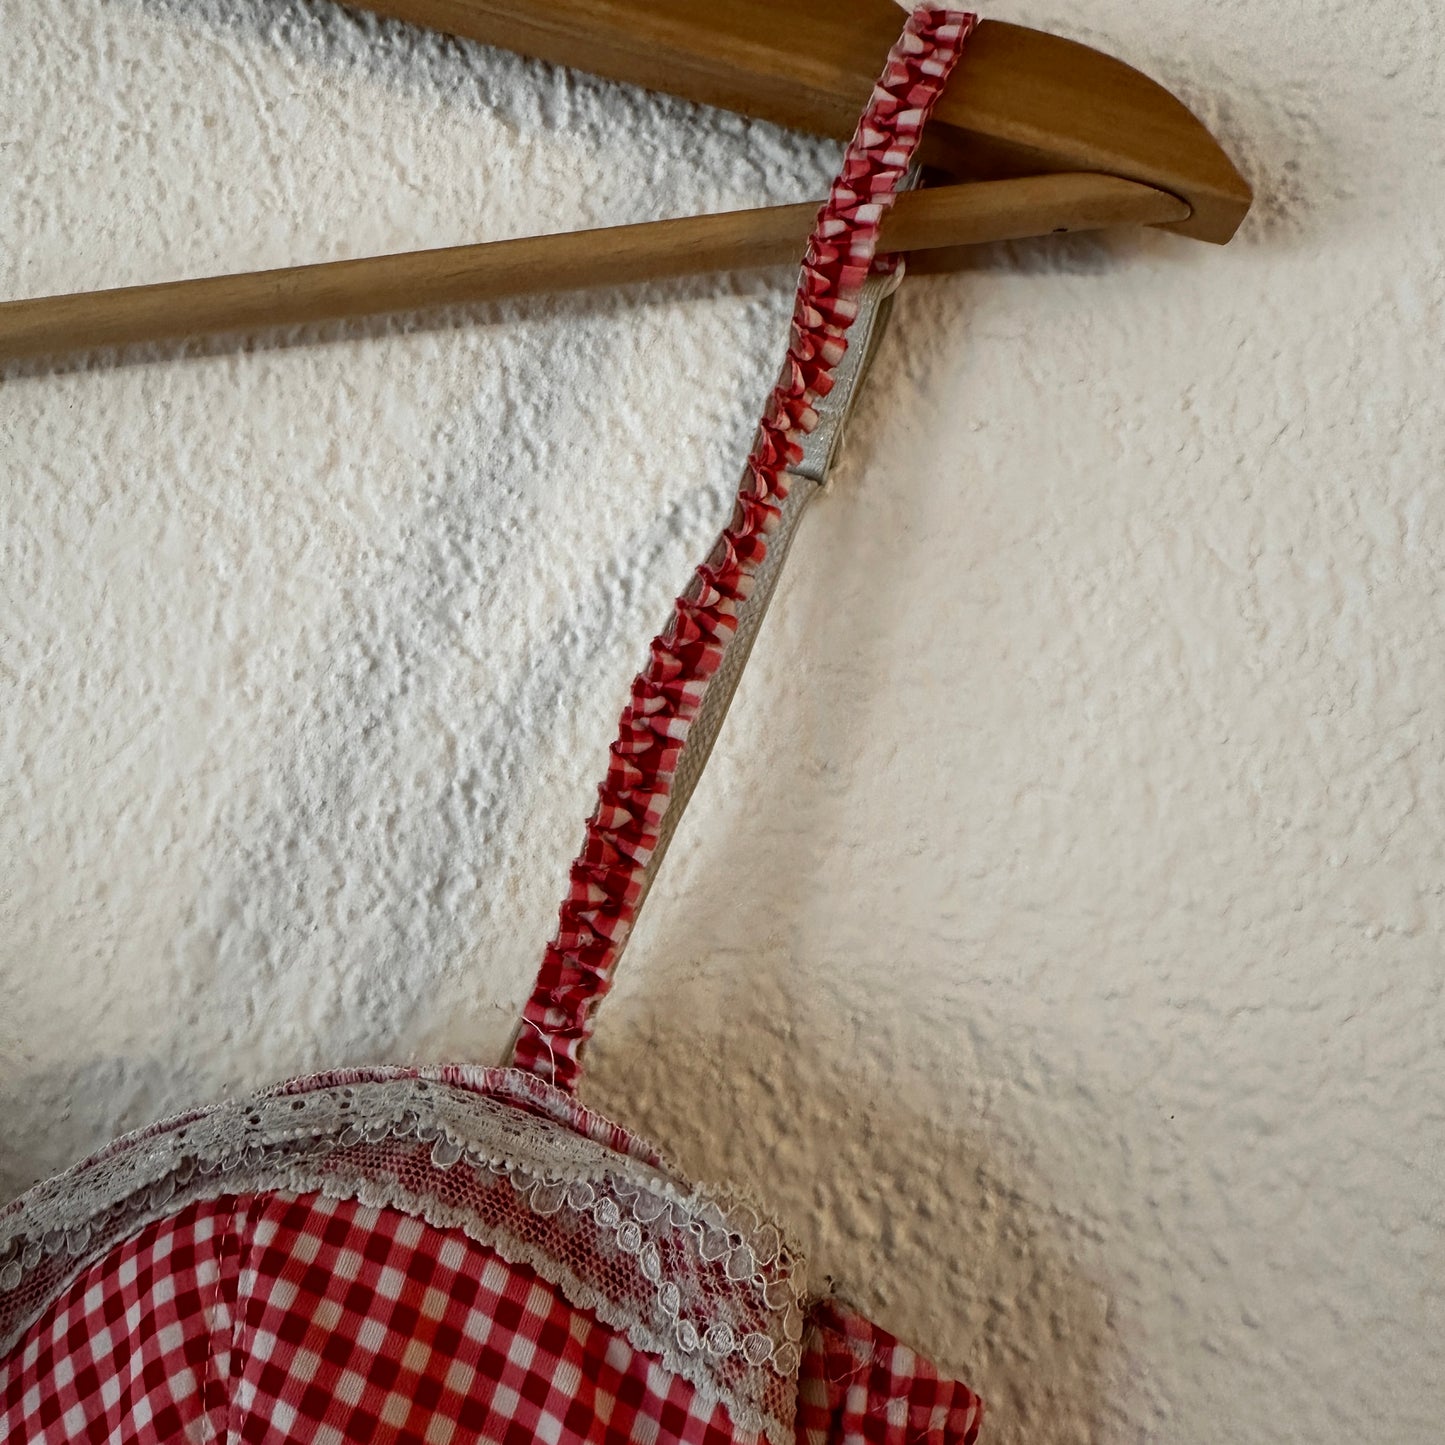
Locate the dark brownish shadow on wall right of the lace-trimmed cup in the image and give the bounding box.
[585,971,1118,1445]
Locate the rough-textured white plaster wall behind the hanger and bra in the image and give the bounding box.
[0,0,1445,1445]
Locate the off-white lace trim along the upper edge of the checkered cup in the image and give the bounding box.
[0,1078,805,1445]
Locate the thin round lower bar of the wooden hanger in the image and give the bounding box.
[0,175,1188,361]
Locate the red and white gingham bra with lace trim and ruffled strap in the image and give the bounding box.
[0,7,981,1445]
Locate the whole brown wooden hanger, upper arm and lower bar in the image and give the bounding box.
[0,0,1251,361]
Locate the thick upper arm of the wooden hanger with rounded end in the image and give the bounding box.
[340,0,1251,243]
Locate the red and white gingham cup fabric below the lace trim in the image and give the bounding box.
[0,1194,756,1445]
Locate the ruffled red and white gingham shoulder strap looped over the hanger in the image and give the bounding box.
[513,6,977,1090]
